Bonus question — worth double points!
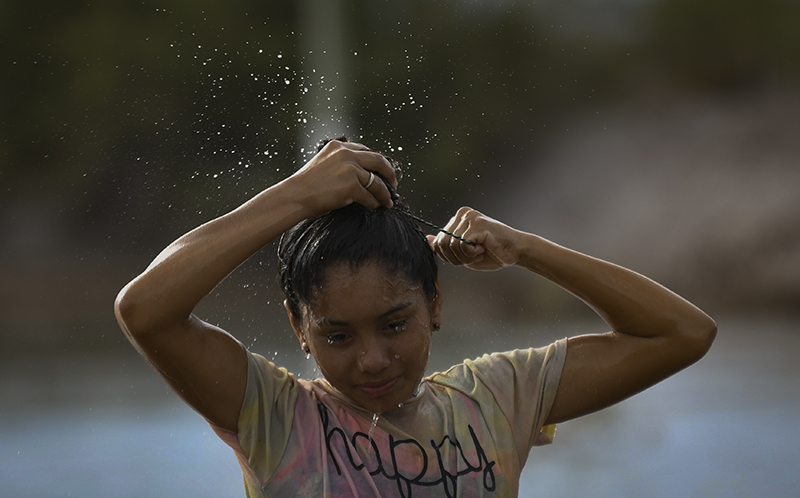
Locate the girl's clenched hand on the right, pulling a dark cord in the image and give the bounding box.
[428,207,522,271]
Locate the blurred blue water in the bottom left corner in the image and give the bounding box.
[0,406,243,498]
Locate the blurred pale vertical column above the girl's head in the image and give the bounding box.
[298,0,355,152]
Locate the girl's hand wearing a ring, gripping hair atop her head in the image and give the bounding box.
[282,140,397,218]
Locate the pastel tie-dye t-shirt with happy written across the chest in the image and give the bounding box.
[209,340,566,498]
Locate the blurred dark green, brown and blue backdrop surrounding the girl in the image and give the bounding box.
[0,0,800,497]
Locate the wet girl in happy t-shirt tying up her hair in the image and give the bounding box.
[116,140,716,497]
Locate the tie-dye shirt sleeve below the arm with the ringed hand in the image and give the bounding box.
[238,351,299,484]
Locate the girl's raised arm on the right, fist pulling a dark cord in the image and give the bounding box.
[431,208,717,423]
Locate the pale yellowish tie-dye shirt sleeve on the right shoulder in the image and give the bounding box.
[434,339,567,455]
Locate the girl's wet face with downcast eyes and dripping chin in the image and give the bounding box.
[289,263,441,413]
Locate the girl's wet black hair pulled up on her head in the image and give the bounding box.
[278,137,438,319]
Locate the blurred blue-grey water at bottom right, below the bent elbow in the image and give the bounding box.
[521,320,800,498]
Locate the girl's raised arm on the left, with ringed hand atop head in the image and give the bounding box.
[115,141,396,431]
